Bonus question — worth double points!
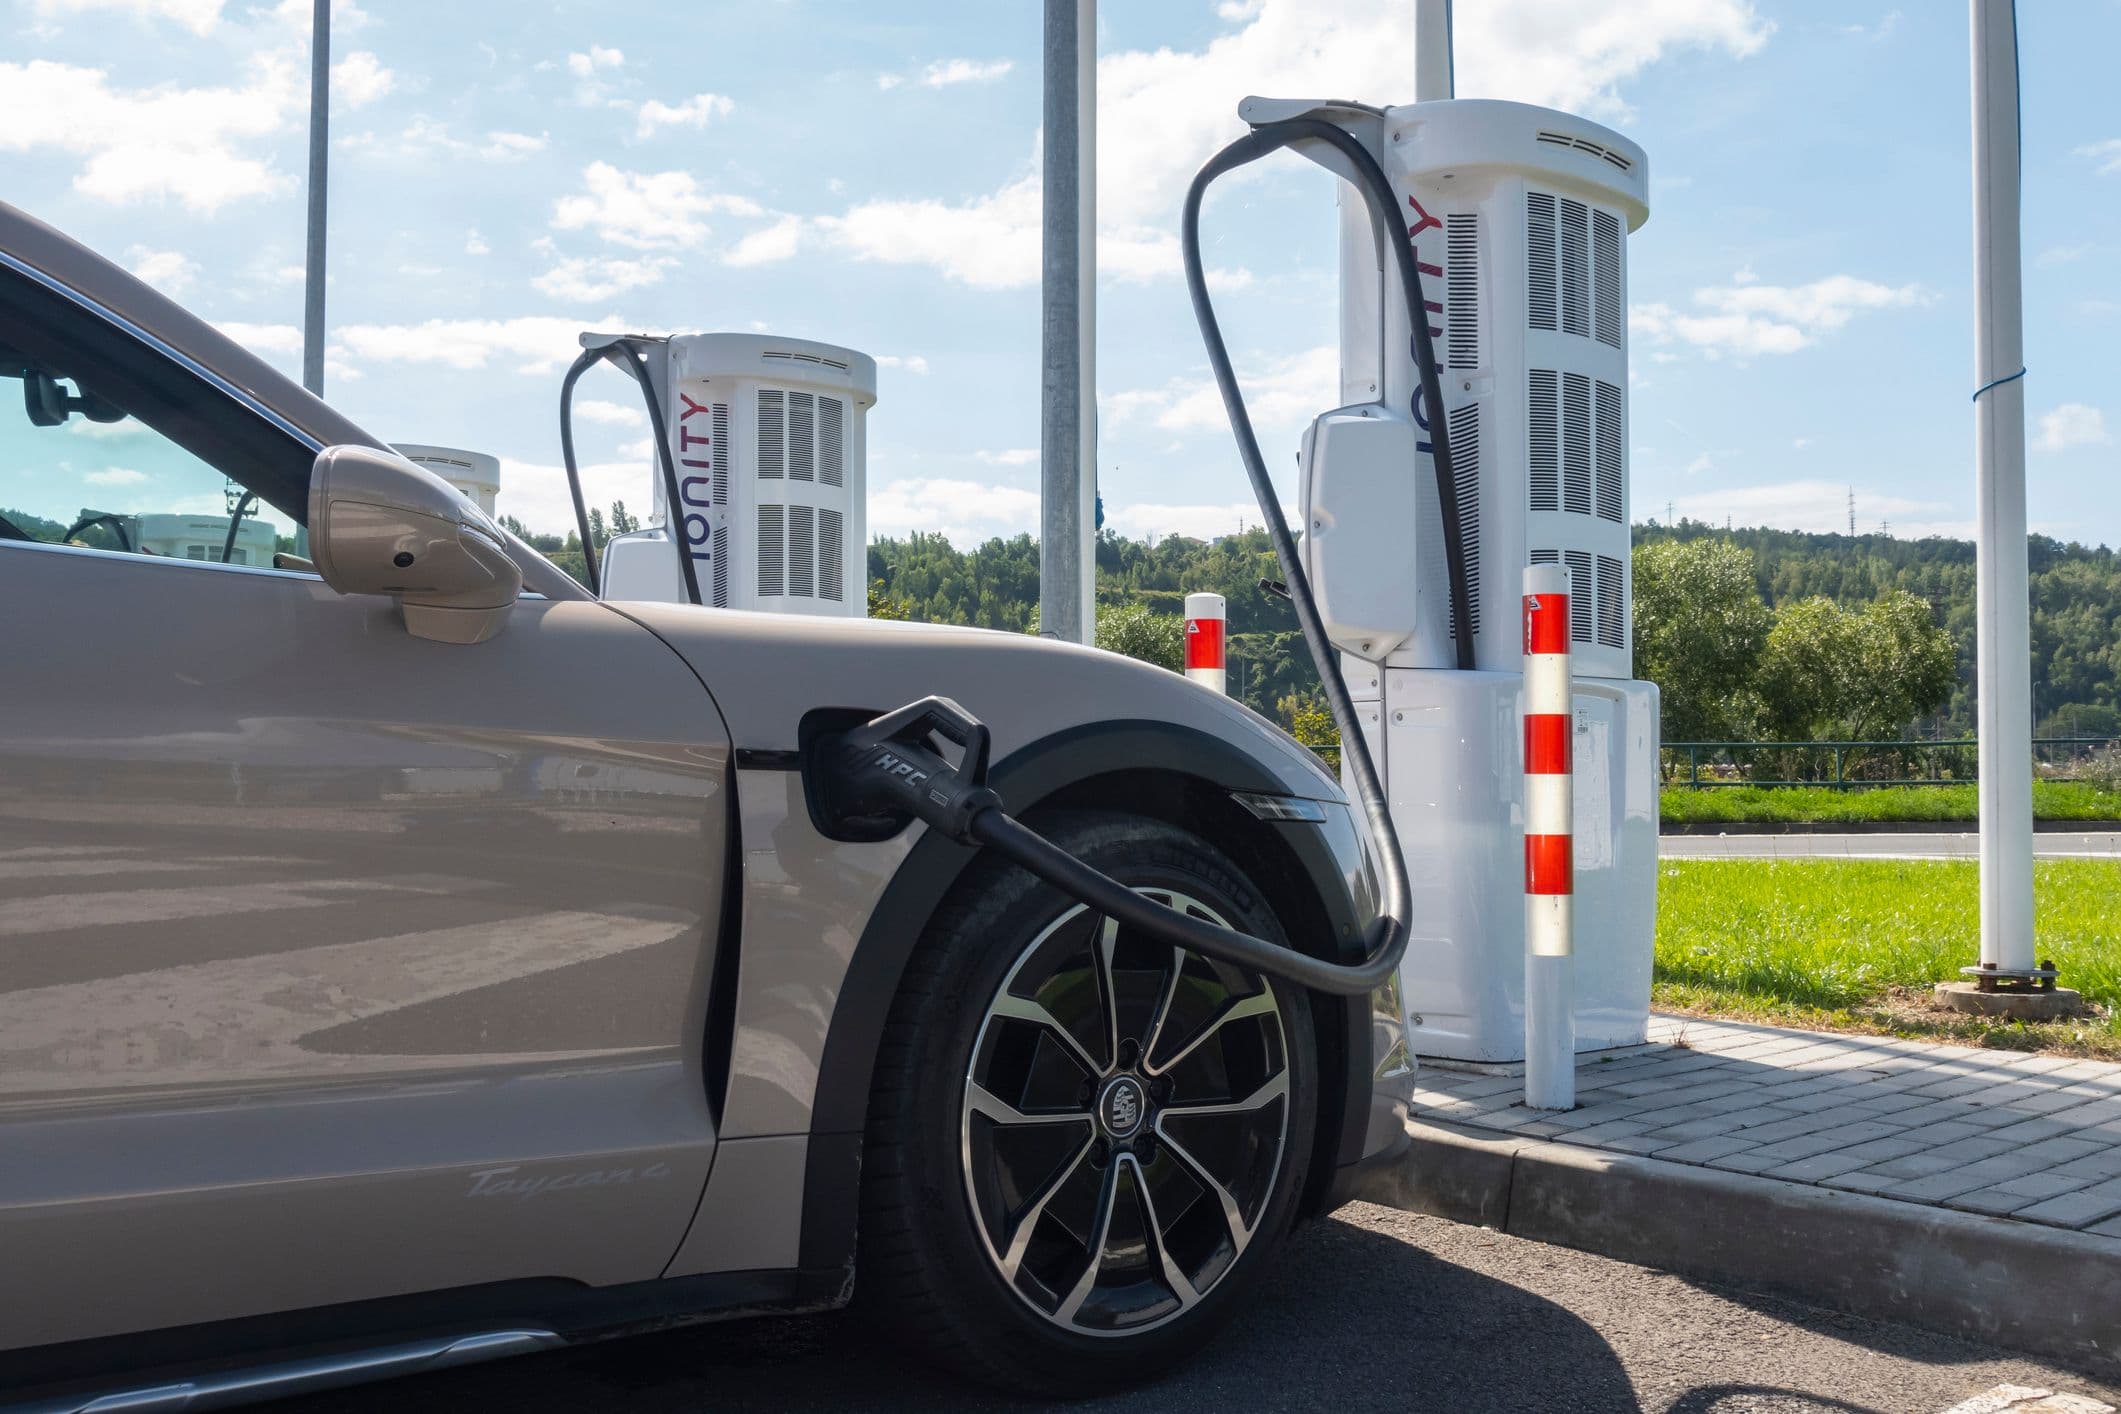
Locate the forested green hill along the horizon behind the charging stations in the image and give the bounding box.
[870,522,2121,736]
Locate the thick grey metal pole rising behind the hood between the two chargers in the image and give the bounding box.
[1039,0,1097,642]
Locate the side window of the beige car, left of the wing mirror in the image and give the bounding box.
[0,343,295,566]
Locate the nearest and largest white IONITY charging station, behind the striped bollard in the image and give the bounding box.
[1239,100,1659,1062]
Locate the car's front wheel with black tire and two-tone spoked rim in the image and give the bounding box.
[855,812,1317,1395]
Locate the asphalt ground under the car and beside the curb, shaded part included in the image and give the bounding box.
[271,1204,2121,1414]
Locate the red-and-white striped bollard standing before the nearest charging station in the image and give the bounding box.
[1525,564,1576,1109]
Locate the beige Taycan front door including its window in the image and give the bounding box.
[0,251,728,1348]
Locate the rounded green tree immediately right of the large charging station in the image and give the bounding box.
[1635,541,1769,742]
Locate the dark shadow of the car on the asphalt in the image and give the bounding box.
[274,1219,1640,1414]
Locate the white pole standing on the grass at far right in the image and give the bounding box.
[1973,0,2032,973]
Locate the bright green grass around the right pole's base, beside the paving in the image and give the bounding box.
[1654,859,2121,1056]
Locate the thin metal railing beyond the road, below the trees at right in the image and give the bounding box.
[1663,736,2121,791]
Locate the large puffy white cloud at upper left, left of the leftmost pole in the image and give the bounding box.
[0,55,299,214]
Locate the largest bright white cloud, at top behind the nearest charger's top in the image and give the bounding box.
[819,0,1773,288]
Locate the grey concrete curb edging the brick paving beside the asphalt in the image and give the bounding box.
[1364,1121,2121,1380]
